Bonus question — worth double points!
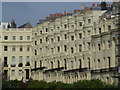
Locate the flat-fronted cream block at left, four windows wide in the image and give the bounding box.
[0,28,32,80]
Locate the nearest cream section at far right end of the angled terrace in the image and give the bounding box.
[92,2,120,84]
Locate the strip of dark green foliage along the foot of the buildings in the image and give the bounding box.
[3,80,118,90]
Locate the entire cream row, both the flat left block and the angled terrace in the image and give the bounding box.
[0,2,120,84]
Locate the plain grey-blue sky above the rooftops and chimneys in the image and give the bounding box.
[2,2,111,26]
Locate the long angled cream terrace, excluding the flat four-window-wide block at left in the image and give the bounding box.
[31,3,118,84]
